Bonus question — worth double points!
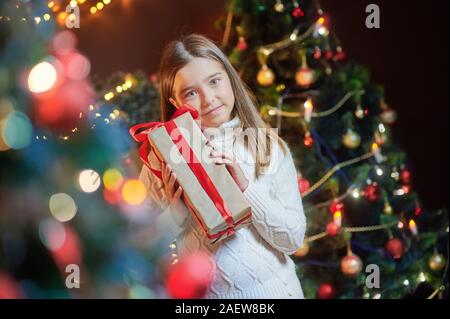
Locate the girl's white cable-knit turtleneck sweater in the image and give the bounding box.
[140,117,306,299]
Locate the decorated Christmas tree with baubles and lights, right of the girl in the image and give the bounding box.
[218,0,448,298]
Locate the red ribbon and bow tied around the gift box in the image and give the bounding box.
[130,105,250,240]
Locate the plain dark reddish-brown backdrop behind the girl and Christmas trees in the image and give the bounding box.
[77,0,449,209]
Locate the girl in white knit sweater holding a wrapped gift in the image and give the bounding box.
[140,34,306,299]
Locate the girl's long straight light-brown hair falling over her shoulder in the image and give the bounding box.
[159,34,286,177]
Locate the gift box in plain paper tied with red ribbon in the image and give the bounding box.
[130,105,251,242]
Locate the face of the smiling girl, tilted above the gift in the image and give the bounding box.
[170,58,234,127]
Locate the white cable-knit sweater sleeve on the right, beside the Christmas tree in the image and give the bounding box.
[244,151,306,255]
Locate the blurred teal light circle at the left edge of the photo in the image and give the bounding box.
[0,111,33,150]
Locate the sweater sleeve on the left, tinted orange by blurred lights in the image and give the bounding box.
[139,165,189,240]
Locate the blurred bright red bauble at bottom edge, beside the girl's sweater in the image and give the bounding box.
[166,251,215,299]
